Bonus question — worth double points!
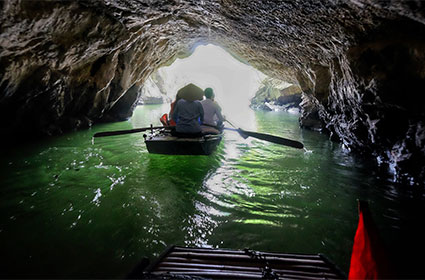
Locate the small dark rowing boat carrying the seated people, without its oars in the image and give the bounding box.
[143,129,223,155]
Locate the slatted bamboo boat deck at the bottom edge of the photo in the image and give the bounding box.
[142,246,346,279]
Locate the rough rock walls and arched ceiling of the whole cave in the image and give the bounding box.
[0,0,425,184]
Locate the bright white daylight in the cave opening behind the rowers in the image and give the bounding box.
[158,44,266,123]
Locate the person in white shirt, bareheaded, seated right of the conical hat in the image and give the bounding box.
[201,88,224,134]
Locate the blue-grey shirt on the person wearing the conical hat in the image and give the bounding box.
[171,99,204,133]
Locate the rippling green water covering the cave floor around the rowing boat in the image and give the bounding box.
[0,105,425,278]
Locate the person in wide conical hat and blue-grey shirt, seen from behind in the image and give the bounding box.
[171,84,204,137]
